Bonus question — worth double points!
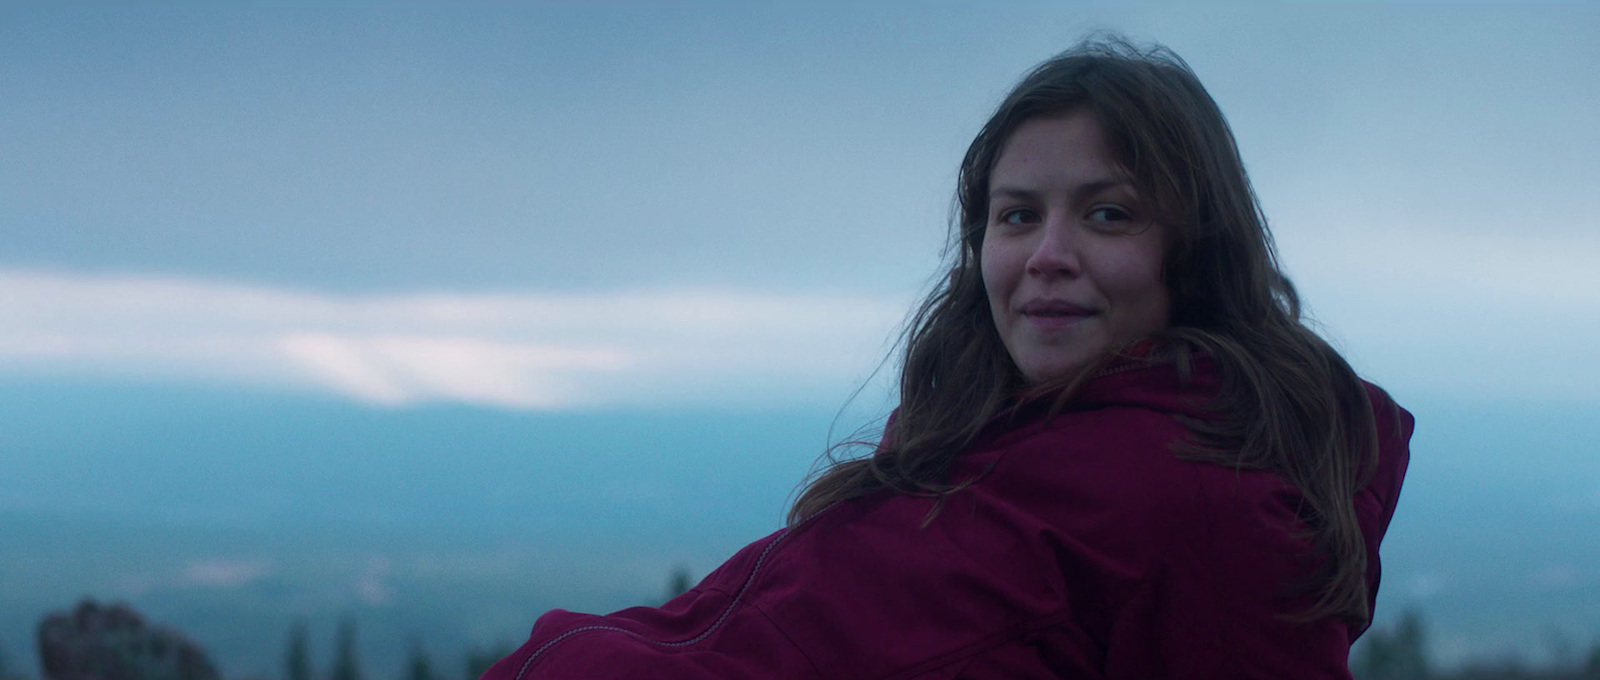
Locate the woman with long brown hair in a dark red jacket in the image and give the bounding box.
[485,43,1411,680]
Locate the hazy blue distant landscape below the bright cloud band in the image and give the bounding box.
[0,382,1600,680]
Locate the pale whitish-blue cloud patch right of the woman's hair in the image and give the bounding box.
[1280,224,1600,400]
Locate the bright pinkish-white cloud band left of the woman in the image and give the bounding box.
[0,270,909,410]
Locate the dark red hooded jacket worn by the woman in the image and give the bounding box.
[483,355,1413,680]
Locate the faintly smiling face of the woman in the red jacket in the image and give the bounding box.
[981,112,1168,384]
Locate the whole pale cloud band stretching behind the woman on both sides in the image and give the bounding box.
[0,227,1600,410]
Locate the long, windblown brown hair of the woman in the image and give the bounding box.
[789,38,1378,626]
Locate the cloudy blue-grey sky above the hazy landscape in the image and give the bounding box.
[0,2,1600,672]
